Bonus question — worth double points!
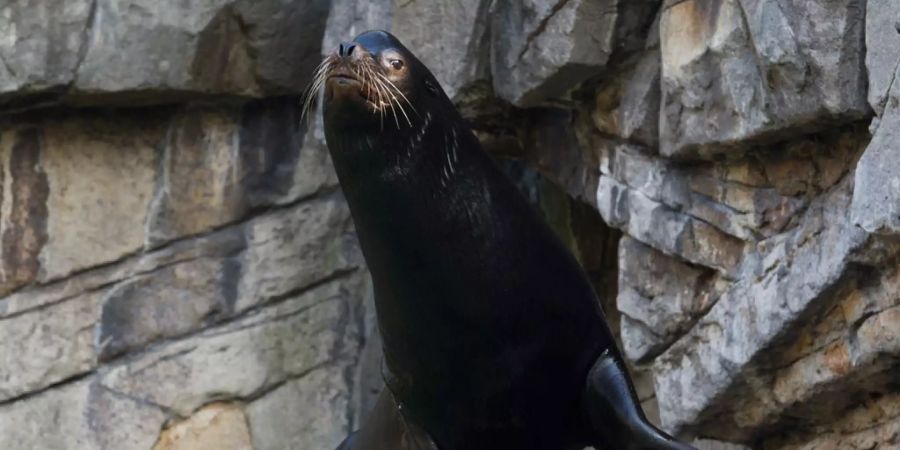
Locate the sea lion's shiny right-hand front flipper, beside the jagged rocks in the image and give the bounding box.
[582,351,696,450]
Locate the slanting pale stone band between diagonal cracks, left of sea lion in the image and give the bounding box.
[0,194,361,402]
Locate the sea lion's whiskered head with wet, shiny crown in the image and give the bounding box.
[306,30,455,134]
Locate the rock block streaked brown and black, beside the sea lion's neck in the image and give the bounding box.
[147,99,337,246]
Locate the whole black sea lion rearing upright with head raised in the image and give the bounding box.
[307,31,691,450]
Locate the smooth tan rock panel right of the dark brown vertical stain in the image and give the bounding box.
[40,114,164,280]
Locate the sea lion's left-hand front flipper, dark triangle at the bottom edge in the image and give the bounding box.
[336,388,438,450]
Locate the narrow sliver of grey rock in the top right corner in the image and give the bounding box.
[866,0,900,115]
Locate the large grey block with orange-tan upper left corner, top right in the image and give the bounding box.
[660,0,870,156]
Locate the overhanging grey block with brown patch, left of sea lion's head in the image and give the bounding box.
[75,0,328,102]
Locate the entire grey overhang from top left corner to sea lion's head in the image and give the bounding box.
[0,0,329,105]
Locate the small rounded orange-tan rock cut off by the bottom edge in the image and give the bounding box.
[153,403,254,450]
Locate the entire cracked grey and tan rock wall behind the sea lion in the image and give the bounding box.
[0,0,900,450]
